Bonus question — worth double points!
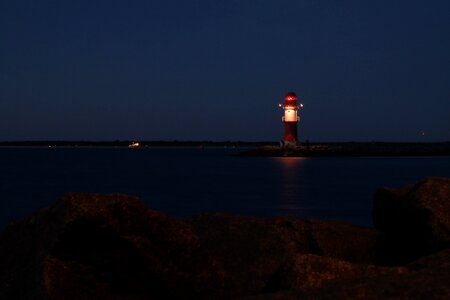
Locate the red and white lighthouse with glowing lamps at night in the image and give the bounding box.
[279,92,303,147]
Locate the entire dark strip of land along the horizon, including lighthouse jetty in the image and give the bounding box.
[0,140,450,157]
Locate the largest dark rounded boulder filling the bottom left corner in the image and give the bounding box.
[0,194,229,300]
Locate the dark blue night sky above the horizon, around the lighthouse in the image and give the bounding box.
[0,0,450,141]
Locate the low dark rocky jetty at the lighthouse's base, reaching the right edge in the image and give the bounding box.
[240,142,450,157]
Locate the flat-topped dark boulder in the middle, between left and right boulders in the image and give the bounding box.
[189,213,380,296]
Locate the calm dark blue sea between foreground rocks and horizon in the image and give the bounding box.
[0,148,450,228]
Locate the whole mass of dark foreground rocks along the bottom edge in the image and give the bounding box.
[0,178,450,300]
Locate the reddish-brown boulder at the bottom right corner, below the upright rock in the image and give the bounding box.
[242,250,450,300]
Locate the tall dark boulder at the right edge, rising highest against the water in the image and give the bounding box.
[373,177,450,265]
